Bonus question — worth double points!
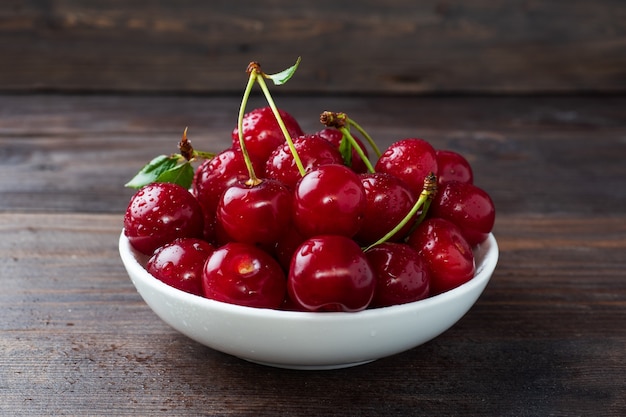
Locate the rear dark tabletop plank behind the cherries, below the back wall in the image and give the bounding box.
[0,95,626,215]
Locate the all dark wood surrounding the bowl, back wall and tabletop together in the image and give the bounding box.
[0,0,626,417]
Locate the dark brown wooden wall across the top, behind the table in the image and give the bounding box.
[0,0,626,94]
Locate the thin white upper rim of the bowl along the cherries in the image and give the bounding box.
[119,229,499,323]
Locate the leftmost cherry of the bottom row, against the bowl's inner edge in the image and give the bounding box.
[146,238,215,296]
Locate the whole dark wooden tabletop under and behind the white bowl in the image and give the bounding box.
[0,95,626,416]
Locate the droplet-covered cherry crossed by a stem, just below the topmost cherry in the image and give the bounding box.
[265,135,343,189]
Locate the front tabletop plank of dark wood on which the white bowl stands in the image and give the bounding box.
[0,213,626,416]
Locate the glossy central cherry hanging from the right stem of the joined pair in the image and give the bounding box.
[293,165,367,238]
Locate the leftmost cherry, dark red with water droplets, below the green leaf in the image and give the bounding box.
[124,183,204,255]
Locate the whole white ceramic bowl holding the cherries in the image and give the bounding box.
[119,233,498,369]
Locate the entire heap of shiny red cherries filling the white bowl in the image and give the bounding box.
[124,107,495,312]
